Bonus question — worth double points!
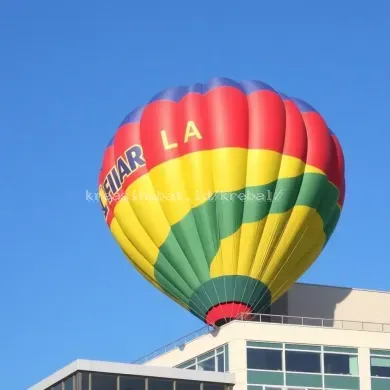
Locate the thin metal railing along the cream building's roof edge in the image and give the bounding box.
[132,313,390,364]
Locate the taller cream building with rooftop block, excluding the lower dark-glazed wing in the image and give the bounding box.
[137,284,390,390]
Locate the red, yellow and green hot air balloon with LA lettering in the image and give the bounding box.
[99,78,345,327]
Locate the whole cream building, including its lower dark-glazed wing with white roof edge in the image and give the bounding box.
[29,283,390,390]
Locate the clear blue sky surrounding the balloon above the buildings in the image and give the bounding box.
[0,0,390,390]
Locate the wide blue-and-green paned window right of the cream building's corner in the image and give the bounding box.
[247,341,362,390]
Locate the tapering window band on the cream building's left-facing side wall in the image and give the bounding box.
[176,344,229,372]
